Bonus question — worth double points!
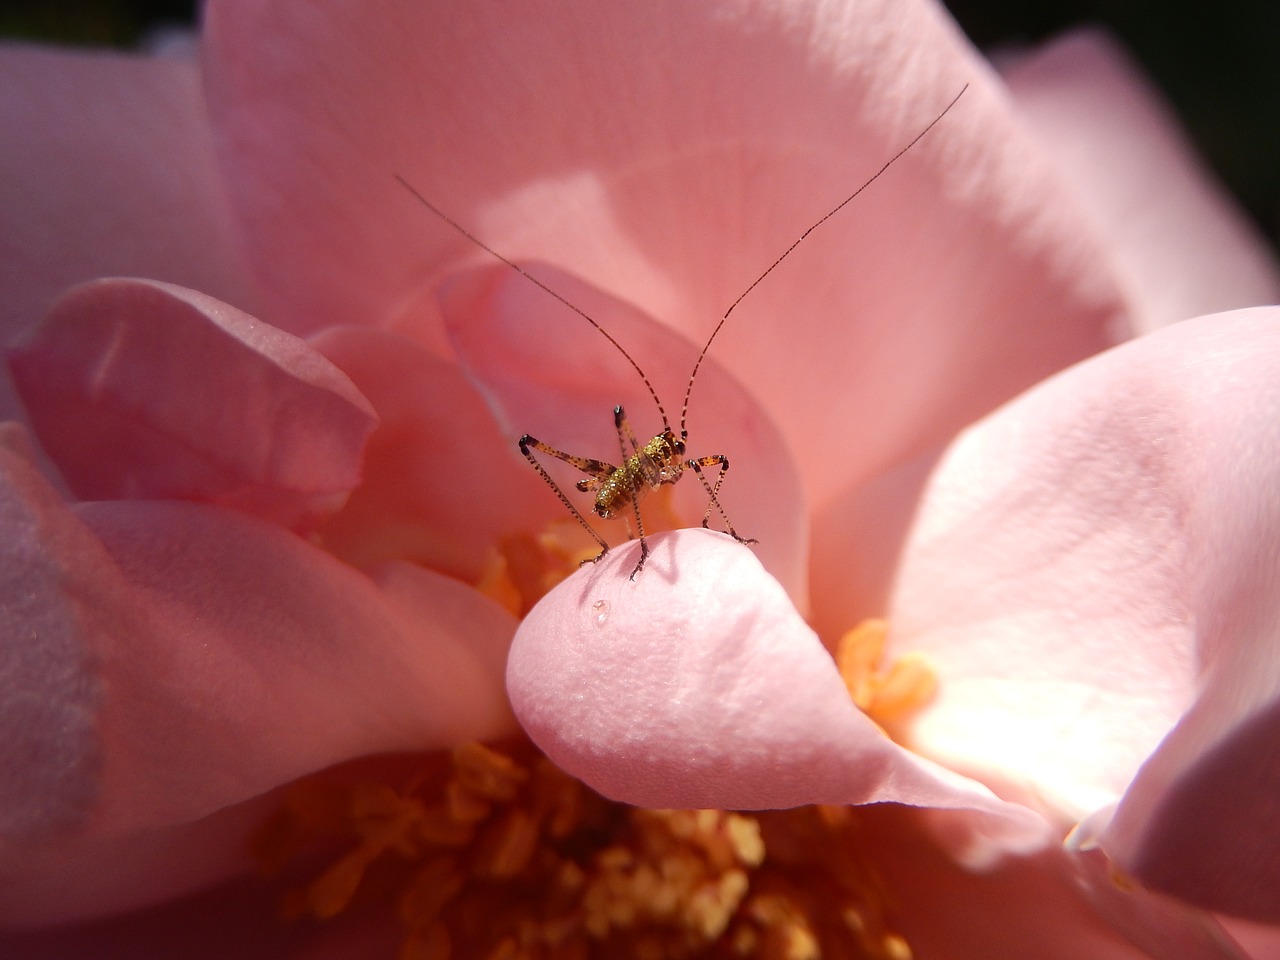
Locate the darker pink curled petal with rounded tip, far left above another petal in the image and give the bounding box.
[10,280,376,535]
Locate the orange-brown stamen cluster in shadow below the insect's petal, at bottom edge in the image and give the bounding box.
[257,742,911,960]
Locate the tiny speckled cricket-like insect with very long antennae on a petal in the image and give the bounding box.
[396,83,969,580]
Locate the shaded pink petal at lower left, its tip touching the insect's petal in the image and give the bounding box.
[79,503,513,818]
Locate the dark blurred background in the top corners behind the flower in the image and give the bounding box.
[0,0,1280,246]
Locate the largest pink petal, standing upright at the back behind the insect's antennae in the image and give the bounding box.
[197,0,1123,519]
